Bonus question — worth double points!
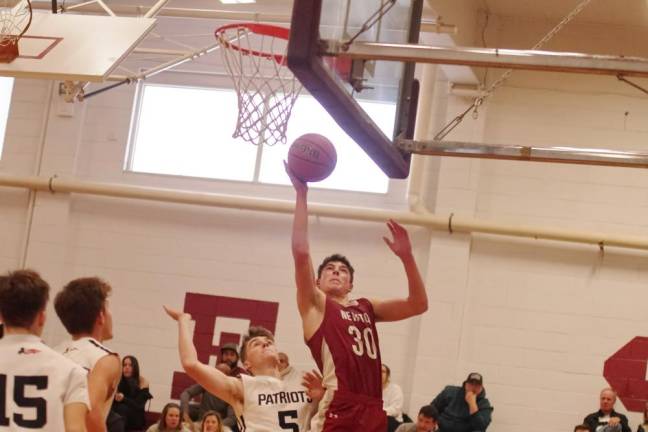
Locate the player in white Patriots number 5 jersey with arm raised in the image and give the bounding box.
[165,307,322,432]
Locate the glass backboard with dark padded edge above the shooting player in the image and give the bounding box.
[288,0,423,178]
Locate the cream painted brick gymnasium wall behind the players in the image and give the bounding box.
[0,10,648,432]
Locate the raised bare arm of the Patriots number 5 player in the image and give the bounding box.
[164,306,243,413]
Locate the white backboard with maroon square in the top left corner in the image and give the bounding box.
[0,11,155,82]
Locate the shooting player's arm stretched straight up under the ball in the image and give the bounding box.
[286,165,325,322]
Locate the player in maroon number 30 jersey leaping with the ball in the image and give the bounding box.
[286,165,428,432]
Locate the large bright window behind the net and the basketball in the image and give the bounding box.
[128,84,396,193]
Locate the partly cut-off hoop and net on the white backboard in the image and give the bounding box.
[0,0,32,63]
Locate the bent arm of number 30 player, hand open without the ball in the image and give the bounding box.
[371,219,428,321]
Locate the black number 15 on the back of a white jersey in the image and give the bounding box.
[0,374,47,429]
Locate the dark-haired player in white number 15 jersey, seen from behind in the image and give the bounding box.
[0,270,88,432]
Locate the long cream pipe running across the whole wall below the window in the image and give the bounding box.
[0,174,648,250]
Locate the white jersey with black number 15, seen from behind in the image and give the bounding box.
[0,334,89,432]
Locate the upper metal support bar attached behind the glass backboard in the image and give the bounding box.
[324,40,648,77]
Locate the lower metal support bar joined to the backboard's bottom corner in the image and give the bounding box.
[396,139,648,168]
